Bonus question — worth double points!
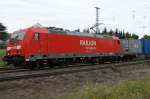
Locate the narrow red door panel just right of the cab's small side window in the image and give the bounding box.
[39,33,48,54]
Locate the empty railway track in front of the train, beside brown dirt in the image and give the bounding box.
[0,60,150,82]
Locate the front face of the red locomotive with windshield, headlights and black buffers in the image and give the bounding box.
[3,30,25,65]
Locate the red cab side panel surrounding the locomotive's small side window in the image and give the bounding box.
[22,28,48,58]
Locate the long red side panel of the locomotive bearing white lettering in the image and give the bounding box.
[48,34,122,54]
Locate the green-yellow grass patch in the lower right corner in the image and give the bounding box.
[65,78,150,99]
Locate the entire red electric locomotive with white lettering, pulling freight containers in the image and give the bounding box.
[3,27,123,69]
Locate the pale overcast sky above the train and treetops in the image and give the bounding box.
[0,0,150,35]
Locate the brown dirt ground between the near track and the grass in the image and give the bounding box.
[0,63,150,99]
